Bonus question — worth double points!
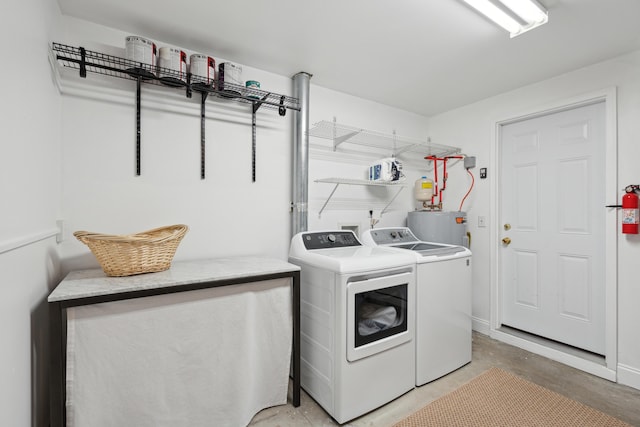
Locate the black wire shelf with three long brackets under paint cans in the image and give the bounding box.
[52,42,300,182]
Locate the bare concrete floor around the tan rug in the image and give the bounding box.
[250,332,640,427]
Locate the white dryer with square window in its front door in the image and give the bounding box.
[289,230,415,424]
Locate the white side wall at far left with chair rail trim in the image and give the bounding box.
[0,0,60,426]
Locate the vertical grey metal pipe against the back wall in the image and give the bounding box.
[292,72,311,235]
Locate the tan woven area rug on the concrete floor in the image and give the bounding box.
[394,368,631,427]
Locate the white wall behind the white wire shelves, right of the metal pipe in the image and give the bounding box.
[309,85,436,236]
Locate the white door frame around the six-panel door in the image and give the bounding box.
[489,87,619,381]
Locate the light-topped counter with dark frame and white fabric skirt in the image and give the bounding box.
[48,257,300,427]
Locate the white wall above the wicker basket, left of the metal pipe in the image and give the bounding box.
[56,18,293,271]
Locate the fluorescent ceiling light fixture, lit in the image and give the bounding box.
[464,0,549,37]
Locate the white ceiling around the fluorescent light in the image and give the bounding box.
[58,0,640,116]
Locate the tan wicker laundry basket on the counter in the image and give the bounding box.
[73,224,189,277]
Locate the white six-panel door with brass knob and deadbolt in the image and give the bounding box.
[498,102,606,355]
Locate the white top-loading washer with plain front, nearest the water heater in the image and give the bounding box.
[362,227,471,386]
